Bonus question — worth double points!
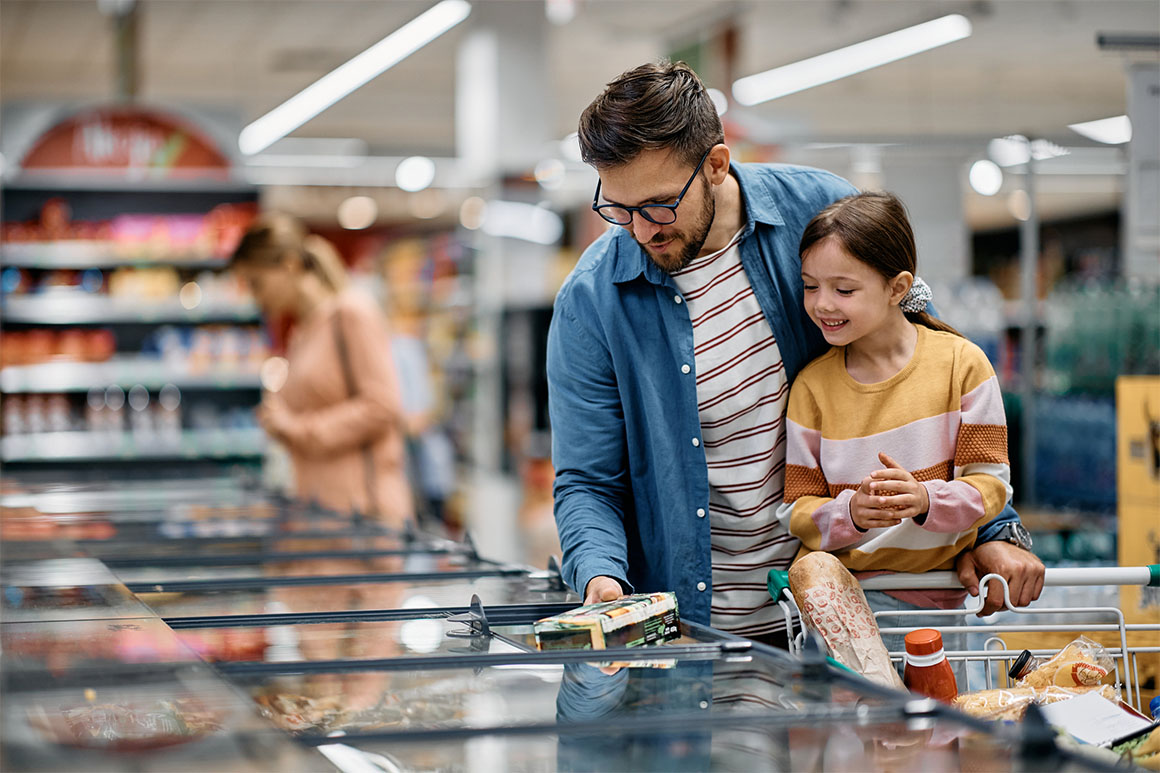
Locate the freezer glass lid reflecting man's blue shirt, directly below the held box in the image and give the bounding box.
[227,646,906,738]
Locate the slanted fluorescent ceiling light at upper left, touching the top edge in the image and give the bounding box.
[238,0,471,156]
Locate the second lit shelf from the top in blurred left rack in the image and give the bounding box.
[0,292,258,325]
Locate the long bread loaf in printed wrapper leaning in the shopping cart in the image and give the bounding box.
[789,552,905,689]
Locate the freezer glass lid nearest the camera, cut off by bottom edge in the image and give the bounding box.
[322,709,1071,773]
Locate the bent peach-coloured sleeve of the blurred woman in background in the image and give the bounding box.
[278,295,403,456]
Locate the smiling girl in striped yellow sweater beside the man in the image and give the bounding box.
[778,193,1012,636]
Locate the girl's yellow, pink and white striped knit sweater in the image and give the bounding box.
[778,325,1012,606]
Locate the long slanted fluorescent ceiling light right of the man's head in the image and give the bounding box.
[733,14,971,107]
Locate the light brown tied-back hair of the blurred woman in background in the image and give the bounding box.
[230,212,347,292]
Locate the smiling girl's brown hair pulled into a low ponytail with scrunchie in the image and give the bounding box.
[798,192,963,337]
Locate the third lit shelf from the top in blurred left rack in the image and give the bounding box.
[0,356,261,395]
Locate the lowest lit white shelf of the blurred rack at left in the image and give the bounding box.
[0,428,266,462]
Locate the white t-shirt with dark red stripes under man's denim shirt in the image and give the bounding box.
[673,227,798,636]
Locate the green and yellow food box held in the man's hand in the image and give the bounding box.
[532,592,680,650]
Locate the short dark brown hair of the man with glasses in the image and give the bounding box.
[579,60,725,168]
